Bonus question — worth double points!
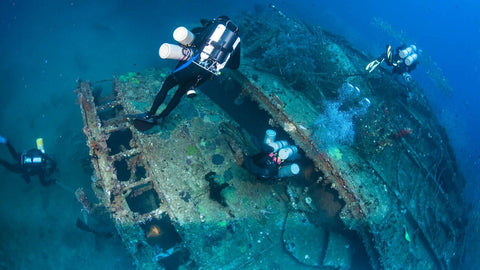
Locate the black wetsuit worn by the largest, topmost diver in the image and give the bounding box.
[146,16,240,119]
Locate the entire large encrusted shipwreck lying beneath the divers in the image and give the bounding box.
[76,6,466,269]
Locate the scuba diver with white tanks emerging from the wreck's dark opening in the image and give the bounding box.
[244,129,300,180]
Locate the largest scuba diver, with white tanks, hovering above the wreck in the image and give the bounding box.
[132,16,240,131]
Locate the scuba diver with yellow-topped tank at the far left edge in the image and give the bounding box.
[0,136,57,186]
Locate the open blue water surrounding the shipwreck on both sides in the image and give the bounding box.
[0,0,480,269]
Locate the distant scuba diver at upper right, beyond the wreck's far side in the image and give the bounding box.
[365,45,420,83]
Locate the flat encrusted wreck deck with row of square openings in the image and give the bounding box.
[78,70,344,269]
